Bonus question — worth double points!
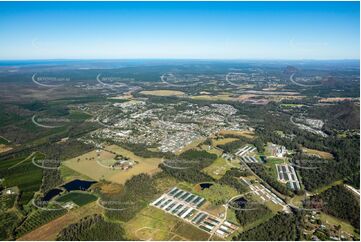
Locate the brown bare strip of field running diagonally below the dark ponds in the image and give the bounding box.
[18,202,101,241]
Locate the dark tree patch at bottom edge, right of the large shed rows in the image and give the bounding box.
[233,213,297,241]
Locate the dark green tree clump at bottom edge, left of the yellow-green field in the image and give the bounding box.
[56,215,126,241]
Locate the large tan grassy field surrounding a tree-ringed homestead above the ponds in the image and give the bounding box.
[63,145,161,184]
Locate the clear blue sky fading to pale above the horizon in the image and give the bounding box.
[0,2,360,60]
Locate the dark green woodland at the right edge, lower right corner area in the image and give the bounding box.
[311,185,360,229]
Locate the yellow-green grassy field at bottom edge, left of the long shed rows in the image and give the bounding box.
[124,207,209,240]
